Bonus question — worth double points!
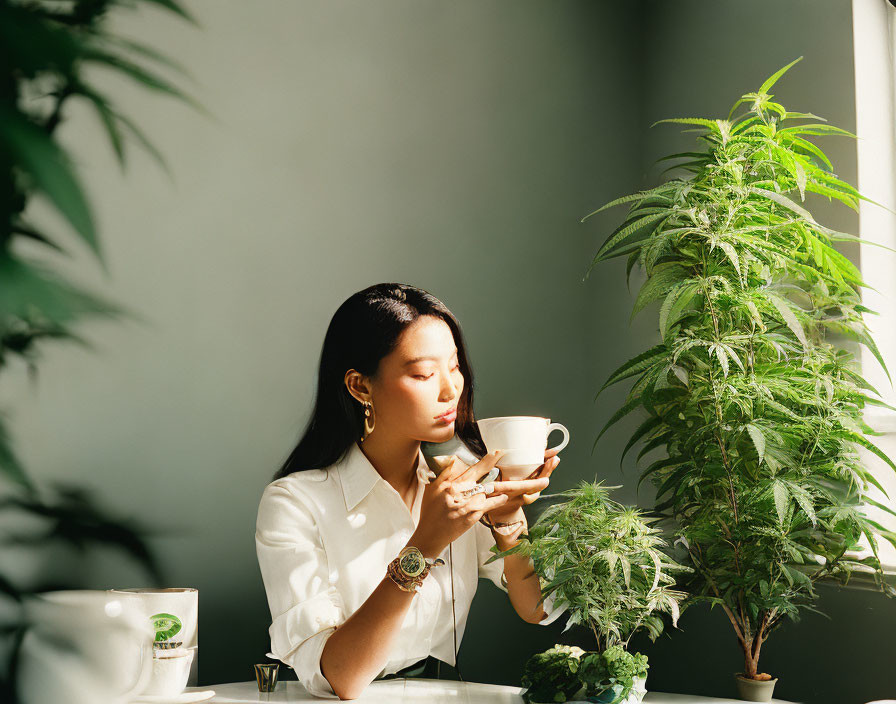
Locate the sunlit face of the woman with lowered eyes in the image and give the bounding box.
[370,316,464,442]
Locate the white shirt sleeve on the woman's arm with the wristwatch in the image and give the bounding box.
[255,482,346,699]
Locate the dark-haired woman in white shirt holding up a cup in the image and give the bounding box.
[255,284,563,699]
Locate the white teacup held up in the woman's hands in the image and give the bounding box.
[476,416,569,479]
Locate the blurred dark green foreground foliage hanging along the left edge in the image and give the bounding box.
[0,0,199,702]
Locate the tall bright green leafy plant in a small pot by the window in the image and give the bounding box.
[586,57,896,677]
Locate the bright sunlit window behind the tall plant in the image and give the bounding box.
[852,0,896,572]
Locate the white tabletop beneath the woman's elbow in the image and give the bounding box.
[186,677,789,704]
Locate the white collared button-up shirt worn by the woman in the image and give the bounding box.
[255,443,566,699]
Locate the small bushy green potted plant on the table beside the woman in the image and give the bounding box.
[489,482,690,704]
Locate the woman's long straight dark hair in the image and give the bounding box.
[274,283,485,479]
